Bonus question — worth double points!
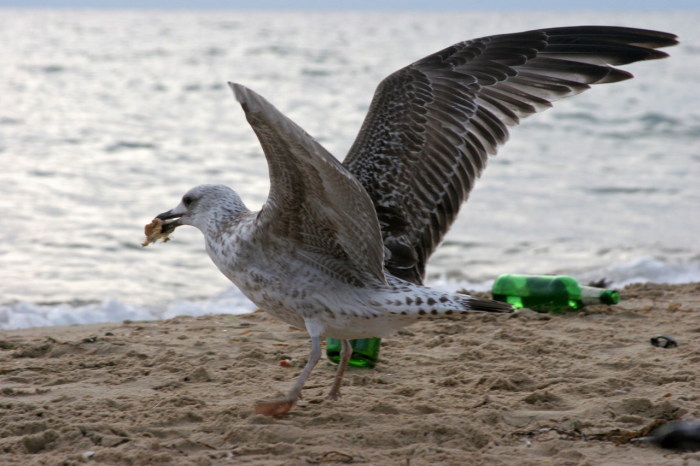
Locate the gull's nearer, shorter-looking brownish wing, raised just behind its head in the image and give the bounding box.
[229,83,386,286]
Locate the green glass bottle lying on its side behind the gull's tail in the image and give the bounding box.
[491,275,620,313]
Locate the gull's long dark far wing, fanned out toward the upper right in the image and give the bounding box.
[343,26,677,283]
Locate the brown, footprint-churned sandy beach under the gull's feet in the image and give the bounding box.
[0,283,700,466]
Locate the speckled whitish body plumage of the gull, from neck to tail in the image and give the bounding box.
[205,202,508,339]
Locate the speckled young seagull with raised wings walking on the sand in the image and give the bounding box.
[149,26,678,416]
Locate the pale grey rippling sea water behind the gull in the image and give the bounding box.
[0,9,700,329]
